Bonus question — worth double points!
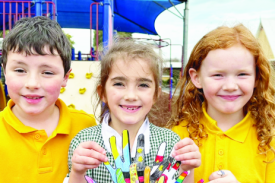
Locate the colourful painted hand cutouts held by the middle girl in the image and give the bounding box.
[85,130,205,183]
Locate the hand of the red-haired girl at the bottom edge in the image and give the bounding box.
[209,170,239,183]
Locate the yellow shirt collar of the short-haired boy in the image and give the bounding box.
[3,99,71,136]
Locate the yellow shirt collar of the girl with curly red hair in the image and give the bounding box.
[202,104,254,143]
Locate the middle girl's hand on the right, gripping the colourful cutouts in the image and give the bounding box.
[172,138,201,171]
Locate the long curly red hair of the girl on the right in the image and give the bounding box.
[167,24,275,160]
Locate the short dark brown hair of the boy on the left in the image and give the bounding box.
[2,16,71,74]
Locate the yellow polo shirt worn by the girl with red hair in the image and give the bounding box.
[172,107,275,183]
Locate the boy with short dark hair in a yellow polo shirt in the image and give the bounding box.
[0,17,96,183]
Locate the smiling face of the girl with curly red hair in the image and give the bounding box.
[189,45,256,116]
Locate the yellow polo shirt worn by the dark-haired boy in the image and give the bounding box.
[0,99,96,183]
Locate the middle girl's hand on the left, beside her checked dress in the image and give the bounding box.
[72,141,108,174]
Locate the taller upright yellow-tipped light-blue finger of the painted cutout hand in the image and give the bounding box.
[122,130,131,171]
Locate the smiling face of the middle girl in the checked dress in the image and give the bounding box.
[103,59,155,128]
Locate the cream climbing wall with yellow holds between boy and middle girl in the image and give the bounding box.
[59,61,101,122]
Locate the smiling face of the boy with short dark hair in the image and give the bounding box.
[5,50,69,115]
